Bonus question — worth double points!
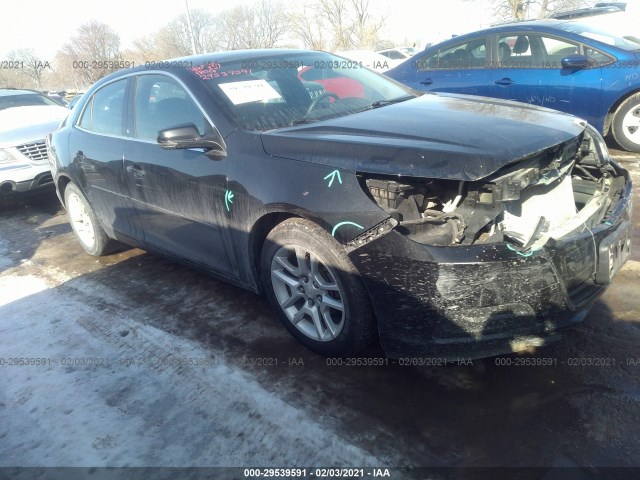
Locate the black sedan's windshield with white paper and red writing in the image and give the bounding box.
[192,52,419,131]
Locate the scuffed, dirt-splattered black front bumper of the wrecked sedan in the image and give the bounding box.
[350,174,632,359]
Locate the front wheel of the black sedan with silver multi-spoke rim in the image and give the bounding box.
[261,218,375,356]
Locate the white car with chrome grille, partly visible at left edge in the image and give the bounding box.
[0,89,69,195]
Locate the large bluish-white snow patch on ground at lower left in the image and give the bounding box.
[0,267,380,467]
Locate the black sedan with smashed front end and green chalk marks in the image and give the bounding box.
[48,50,632,358]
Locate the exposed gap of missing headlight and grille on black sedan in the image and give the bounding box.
[359,126,626,254]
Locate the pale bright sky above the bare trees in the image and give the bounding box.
[0,0,496,61]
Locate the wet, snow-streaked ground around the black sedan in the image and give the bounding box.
[0,152,640,476]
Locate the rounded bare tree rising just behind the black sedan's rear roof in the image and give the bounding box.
[58,20,122,84]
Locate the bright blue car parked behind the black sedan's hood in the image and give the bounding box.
[385,20,640,152]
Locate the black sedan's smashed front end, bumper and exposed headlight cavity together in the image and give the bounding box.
[347,125,632,358]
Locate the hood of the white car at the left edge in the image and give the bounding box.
[0,105,69,147]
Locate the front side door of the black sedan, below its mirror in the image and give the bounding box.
[124,74,238,278]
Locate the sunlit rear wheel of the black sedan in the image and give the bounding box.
[64,183,115,256]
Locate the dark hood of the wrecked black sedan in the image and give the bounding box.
[262,94,585,181]
